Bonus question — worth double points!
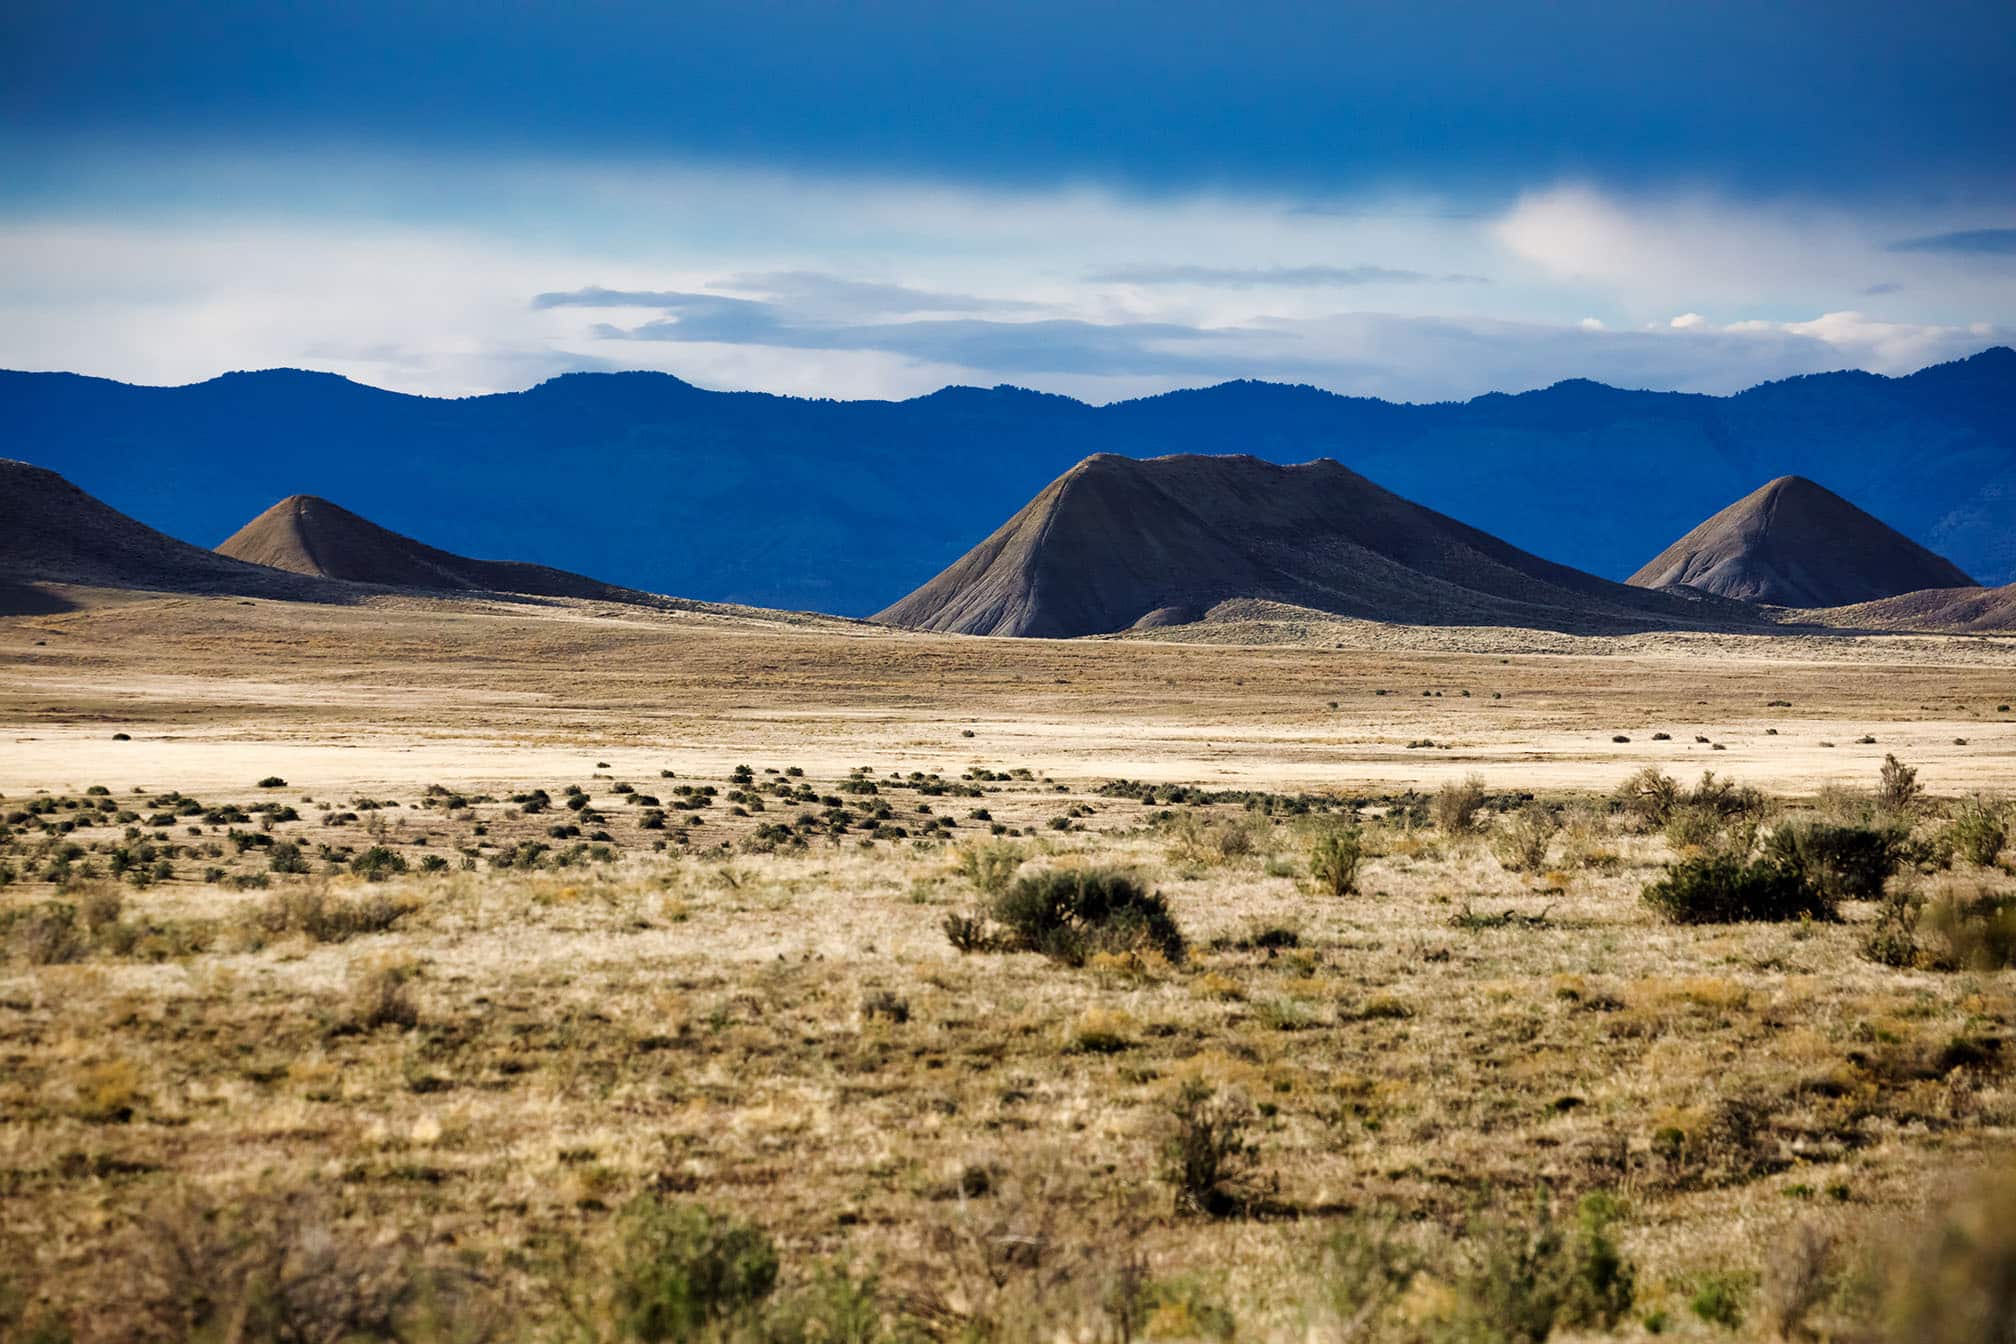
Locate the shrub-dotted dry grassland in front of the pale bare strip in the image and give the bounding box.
[0,655,2016,1344]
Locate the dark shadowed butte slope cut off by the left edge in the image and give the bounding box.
[0,457,338,615]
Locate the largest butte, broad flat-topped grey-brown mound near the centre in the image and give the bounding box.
[875,453,1742,639]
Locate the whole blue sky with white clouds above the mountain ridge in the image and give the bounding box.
[0,0,2016,399]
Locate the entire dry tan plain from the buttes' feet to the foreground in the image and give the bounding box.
[0,596,2016,1340]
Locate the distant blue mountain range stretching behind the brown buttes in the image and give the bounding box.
[0,349,2016,615]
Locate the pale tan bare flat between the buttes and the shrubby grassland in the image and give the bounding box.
[0,598,2016,794]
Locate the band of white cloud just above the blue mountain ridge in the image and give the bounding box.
[0,169,2016,401]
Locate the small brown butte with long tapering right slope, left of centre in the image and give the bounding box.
[218,494,653,602]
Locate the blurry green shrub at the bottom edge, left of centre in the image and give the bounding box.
[613,1195,778,1342]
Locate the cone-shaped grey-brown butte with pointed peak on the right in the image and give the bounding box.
[1625,476,1976,607]
